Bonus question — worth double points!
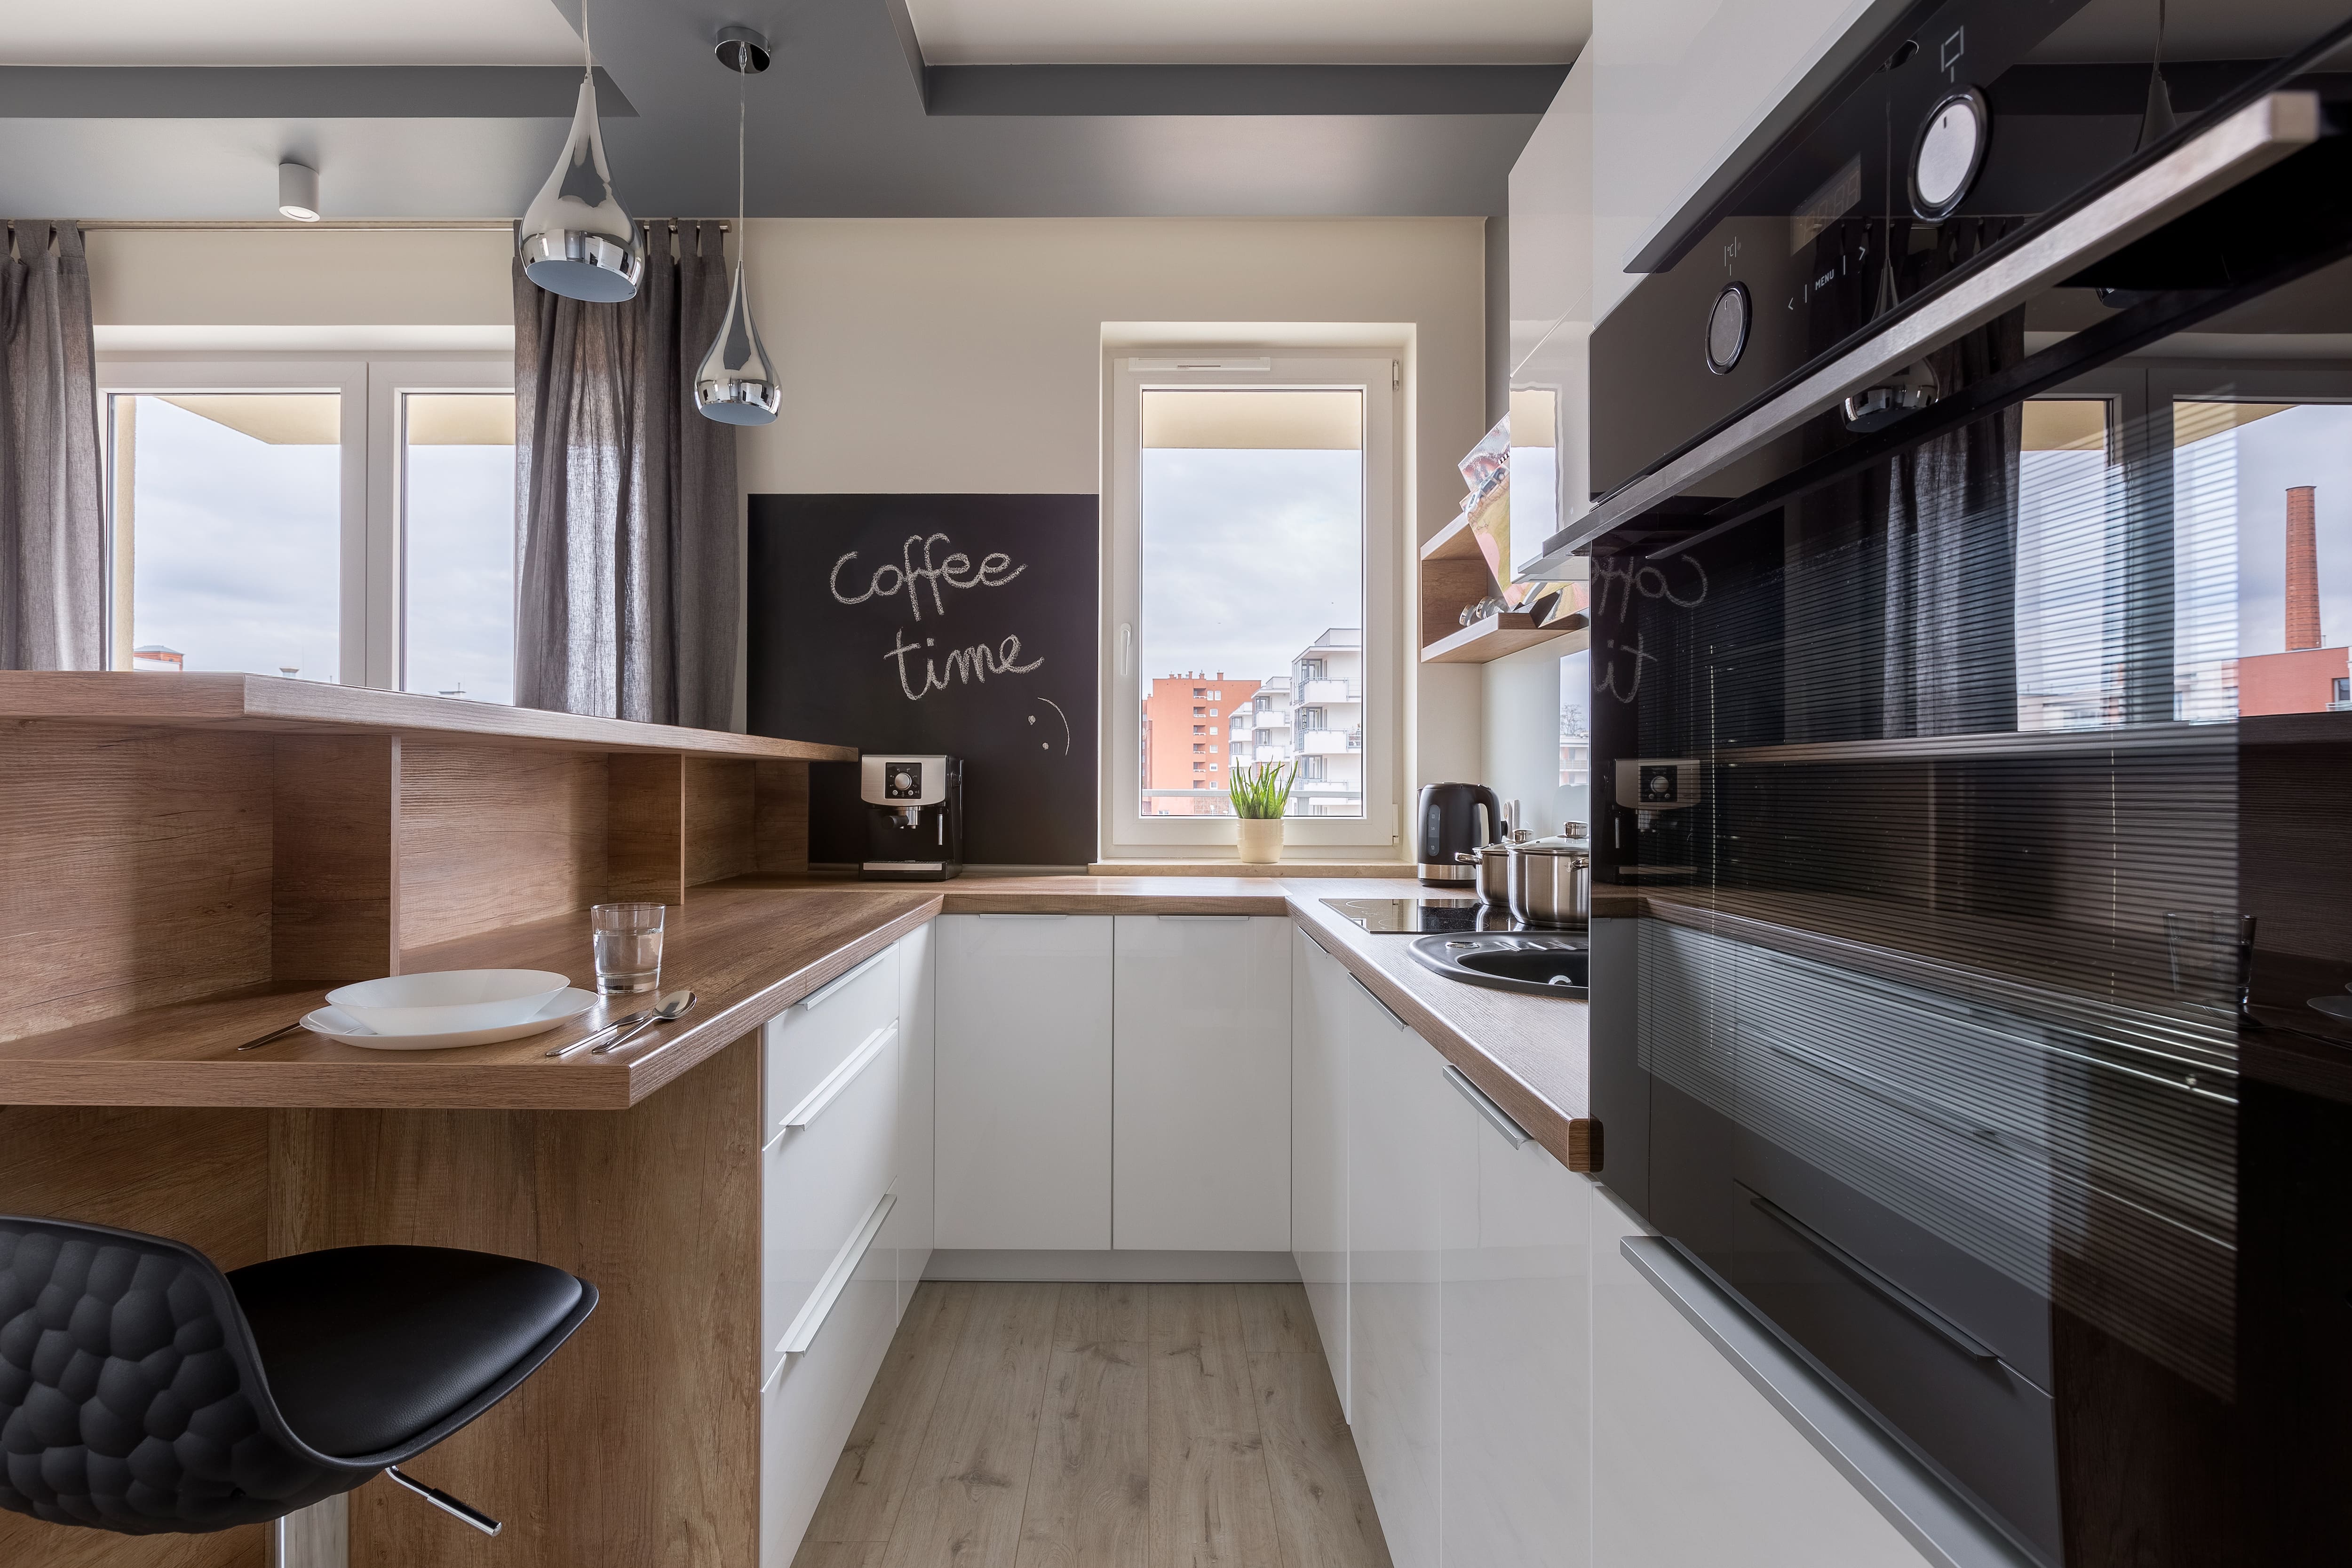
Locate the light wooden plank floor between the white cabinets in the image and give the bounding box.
[795,1281,1388,1568]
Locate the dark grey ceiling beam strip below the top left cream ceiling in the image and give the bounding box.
[0,66,637,120]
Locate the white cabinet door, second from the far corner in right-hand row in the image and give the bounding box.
[1334,975,1470,1568]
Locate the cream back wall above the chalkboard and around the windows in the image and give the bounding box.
[89,219,1484,797]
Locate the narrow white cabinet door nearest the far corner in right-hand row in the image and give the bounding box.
[1291,928,1355,1420]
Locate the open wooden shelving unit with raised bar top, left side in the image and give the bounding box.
[0,673,856,1041]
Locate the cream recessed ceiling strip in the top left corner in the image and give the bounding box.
[0,0,581,66]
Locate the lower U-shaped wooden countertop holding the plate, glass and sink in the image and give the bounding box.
[0,874,1599,1171]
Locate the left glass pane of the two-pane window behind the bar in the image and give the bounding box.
[111,393,343,682]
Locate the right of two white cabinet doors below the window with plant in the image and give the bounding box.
[1110,914,1291,1253]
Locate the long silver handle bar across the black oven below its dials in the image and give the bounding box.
[1519,92,2319,581]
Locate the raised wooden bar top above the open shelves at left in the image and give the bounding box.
[0,670,858,762]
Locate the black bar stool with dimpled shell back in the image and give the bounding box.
[0,1215,595,1535]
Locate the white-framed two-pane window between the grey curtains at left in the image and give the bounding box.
[99,353,515,701]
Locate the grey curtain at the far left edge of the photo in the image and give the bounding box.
[0,219,106,670]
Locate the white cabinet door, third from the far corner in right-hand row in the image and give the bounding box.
[1439,1067,1590,1568]
